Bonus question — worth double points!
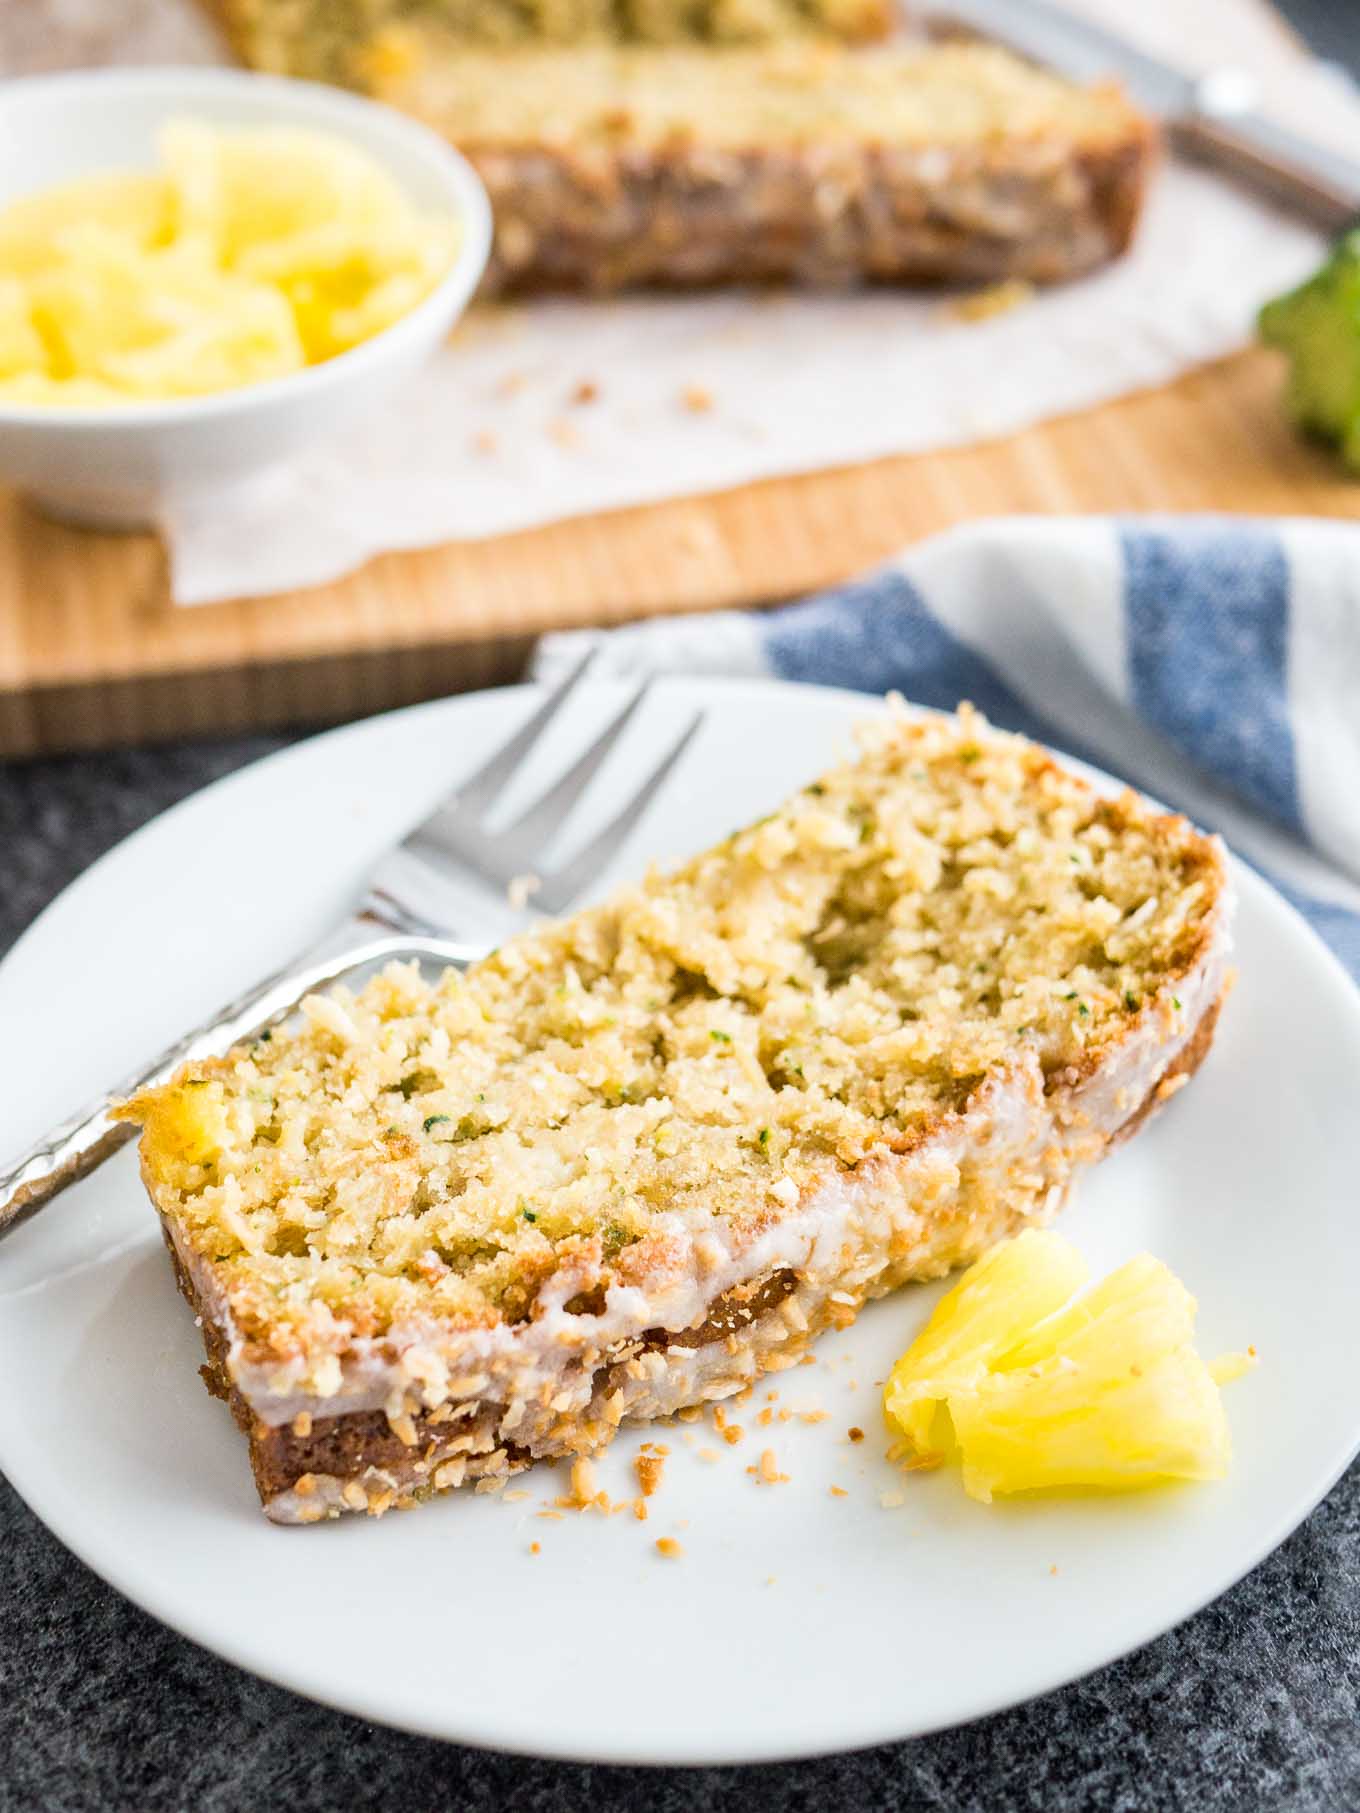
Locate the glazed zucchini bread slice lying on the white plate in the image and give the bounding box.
[121,709,1231,1523]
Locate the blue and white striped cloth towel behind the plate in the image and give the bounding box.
[535,517,1360,981]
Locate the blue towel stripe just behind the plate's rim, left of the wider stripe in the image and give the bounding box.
[762,571,1054,743]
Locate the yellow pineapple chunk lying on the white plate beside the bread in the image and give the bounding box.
[883,1229,1251,1503]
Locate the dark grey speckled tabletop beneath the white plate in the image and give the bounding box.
[0,0,1360,1813]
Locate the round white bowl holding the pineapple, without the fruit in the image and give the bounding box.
[0,69,491,528]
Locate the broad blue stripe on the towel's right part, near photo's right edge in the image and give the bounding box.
[1121,522,1304,836]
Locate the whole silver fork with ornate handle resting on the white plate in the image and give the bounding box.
[0,654,704,1236]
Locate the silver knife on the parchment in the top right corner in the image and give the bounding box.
[918,0,1360,234]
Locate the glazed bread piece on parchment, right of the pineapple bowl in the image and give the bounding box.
[377,44,1157,294]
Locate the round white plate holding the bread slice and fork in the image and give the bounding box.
[0,682,1360,1762]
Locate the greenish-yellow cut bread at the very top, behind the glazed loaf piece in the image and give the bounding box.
[209,0,896,89]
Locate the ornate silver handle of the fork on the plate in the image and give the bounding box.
[0,921,482,1238]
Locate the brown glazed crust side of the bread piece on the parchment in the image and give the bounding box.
[462,127,1155,294]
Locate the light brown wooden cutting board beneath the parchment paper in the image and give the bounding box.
[0,0,1360,756]
